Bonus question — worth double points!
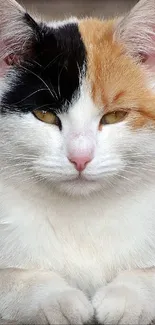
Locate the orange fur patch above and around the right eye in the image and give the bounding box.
[79,19,155,128]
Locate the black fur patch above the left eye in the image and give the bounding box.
[1,22,86,113]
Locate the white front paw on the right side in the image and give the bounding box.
[92,272,155,325]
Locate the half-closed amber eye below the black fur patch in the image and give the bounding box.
[33,110,61,129]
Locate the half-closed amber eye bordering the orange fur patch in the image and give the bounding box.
[100,111,127,125]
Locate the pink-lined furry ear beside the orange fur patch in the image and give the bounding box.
[114,0,155,69]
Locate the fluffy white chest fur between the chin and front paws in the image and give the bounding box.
[0,181,155,292]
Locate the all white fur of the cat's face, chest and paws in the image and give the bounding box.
[0,0,155,324]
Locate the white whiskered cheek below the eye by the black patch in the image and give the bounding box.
[0,113,76,183]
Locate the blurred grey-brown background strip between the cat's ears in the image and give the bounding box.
[18,0,138,20]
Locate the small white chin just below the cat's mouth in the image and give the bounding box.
[58,178,102,197]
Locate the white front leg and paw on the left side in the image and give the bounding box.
[0,270,94,325]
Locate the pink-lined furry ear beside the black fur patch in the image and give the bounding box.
[0,0,39,76]
